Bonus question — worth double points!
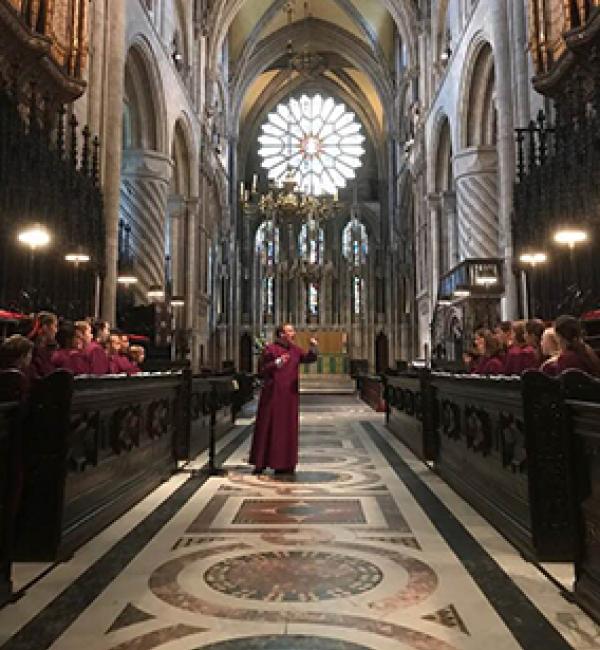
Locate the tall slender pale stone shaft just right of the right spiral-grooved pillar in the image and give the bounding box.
[490,0,517,319]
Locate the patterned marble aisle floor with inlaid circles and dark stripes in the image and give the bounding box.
[0,396,600,650]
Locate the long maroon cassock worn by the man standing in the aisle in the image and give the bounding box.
[250,341,317,470]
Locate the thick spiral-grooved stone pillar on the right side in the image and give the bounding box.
[454,147,500,260]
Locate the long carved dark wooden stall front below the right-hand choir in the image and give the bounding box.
[385,372,574,561]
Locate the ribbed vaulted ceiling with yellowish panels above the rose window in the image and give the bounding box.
[222,0,416,141]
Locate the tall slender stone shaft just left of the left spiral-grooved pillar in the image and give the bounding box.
[102,2,125,323]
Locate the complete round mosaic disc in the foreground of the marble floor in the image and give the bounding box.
[204,551,383,602]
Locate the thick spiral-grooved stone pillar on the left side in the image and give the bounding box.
[120,150,172,301]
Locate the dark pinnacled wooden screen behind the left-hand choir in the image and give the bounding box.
[0,82,105,318]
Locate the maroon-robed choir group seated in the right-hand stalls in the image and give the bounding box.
[464,315,600,376]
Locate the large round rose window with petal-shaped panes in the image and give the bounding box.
[258,94,365,196]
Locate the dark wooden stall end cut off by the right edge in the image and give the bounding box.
[563,370,600,621]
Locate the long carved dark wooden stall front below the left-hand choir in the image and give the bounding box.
[16,371,182,561]
